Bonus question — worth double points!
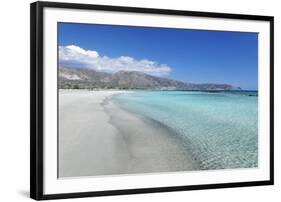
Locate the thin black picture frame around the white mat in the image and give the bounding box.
[30,2,274,200]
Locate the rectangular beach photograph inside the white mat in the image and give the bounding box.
[57,23,259,178]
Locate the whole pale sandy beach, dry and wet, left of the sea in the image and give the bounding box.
[59,90,197,177]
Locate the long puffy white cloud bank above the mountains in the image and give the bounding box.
[59,45,172,76]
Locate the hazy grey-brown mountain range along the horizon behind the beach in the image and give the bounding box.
[59,66,241,91]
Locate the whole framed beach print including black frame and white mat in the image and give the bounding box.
[30,2,274,200]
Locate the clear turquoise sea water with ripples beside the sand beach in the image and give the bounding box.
[113,91,258,169]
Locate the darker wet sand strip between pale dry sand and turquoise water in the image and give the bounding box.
[105,95,199,174]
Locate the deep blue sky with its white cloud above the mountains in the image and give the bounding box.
[59,23,258,89]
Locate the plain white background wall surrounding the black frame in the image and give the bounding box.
[0,0,281,202]
